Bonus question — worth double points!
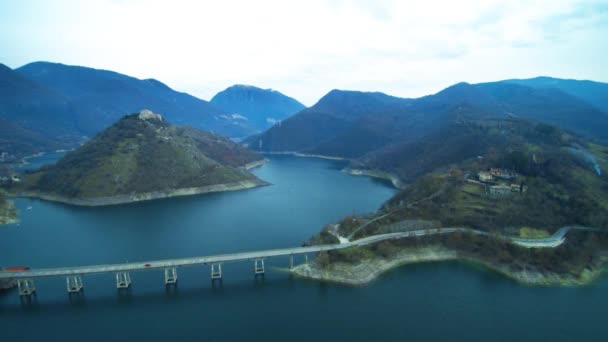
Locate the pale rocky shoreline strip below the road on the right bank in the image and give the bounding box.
[290,246,608,286]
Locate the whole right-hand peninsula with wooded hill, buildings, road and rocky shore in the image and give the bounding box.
[292,117,608,285]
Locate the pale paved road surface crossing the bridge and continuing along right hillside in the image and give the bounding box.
[0,226,600,279]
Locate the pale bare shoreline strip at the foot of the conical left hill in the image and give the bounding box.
[10,179,270,207]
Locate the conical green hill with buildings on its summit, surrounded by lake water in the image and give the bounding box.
[10,110,264,205]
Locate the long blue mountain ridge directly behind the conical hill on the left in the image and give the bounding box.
[15,62,251,136]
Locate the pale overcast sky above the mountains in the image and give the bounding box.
[0,0,608,106]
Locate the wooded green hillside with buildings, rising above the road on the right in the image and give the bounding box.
[328,118,608,235]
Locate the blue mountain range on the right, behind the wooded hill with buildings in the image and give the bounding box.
[245,78,608,181]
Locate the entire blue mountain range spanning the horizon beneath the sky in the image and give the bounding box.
[0,62,608,182]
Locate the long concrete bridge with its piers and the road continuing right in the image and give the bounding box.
[0,227,599,296]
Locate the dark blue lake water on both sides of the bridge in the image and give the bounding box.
[0,156,608,342]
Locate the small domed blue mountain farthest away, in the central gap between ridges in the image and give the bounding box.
[210,85,306,132]
